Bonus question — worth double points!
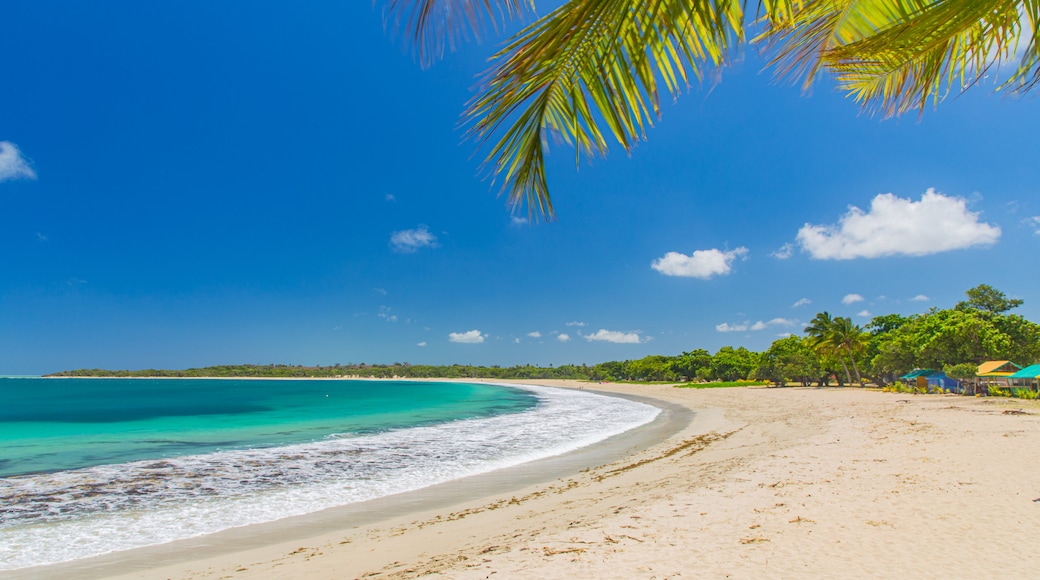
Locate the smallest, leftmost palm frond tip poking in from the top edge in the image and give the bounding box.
[383,0,535,64]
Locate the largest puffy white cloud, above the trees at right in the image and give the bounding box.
[798,189,1000,260]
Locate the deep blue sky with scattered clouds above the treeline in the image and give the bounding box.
[0,0,1040,374]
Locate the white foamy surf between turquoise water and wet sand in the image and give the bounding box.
[0,387,659,570]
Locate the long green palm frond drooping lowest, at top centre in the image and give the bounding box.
[466,0,743,219]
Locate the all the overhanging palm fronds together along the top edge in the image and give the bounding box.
[385,0,1040,219]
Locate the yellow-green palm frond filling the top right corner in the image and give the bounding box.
[760,0,1037,116]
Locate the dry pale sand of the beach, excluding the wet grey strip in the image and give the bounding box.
[12,380,1040,579]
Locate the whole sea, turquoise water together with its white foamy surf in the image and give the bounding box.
[0,378,658,570]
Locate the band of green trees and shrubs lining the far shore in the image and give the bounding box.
[48,284,1040,395]
